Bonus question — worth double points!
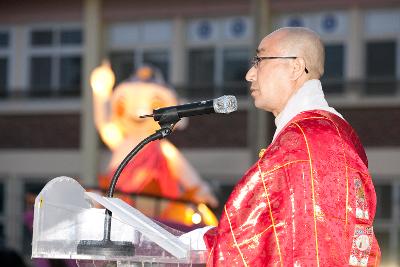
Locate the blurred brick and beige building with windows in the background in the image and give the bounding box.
[0,0,400,266]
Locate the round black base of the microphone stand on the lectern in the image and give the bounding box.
[77,240,135,256]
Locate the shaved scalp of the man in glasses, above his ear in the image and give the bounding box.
[265,27,325,79]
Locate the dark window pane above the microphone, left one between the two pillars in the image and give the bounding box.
[188,48,214,97]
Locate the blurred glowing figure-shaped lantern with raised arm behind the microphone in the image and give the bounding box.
[90,62,218,225]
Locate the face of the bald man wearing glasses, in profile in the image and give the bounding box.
[246,35,292,116]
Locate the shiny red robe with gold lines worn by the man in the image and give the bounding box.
[204,110,380,266]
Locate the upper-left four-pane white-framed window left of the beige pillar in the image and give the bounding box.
[29,27,82,96]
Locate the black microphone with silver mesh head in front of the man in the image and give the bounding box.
[140,95,237,121]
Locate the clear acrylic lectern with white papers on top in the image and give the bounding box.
[32,177,207,266]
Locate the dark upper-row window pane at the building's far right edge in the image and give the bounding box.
[365,40,397,94]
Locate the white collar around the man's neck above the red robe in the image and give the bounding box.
[273,80,343,139]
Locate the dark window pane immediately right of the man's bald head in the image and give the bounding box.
[322,44,344,94]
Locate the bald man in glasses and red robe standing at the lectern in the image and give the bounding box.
[180,28,380,266]
